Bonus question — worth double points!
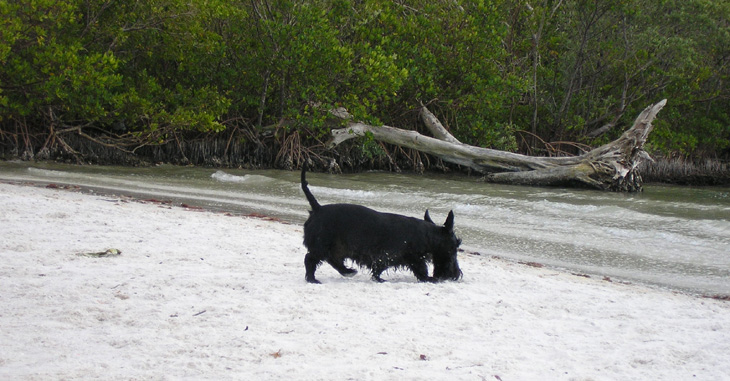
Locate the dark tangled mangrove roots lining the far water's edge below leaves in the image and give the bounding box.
[0,129,730,186]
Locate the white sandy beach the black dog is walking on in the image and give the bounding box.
[0,184,730,381]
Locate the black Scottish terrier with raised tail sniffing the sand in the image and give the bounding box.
[302,165,462,283]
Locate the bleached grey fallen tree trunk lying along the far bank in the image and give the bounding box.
[329,99,667,192]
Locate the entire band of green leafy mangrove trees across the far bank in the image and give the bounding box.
[0,0,730,155]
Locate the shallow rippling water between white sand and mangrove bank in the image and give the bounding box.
[0,162,730,294]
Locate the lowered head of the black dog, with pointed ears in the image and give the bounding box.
[424,211,463,280]
